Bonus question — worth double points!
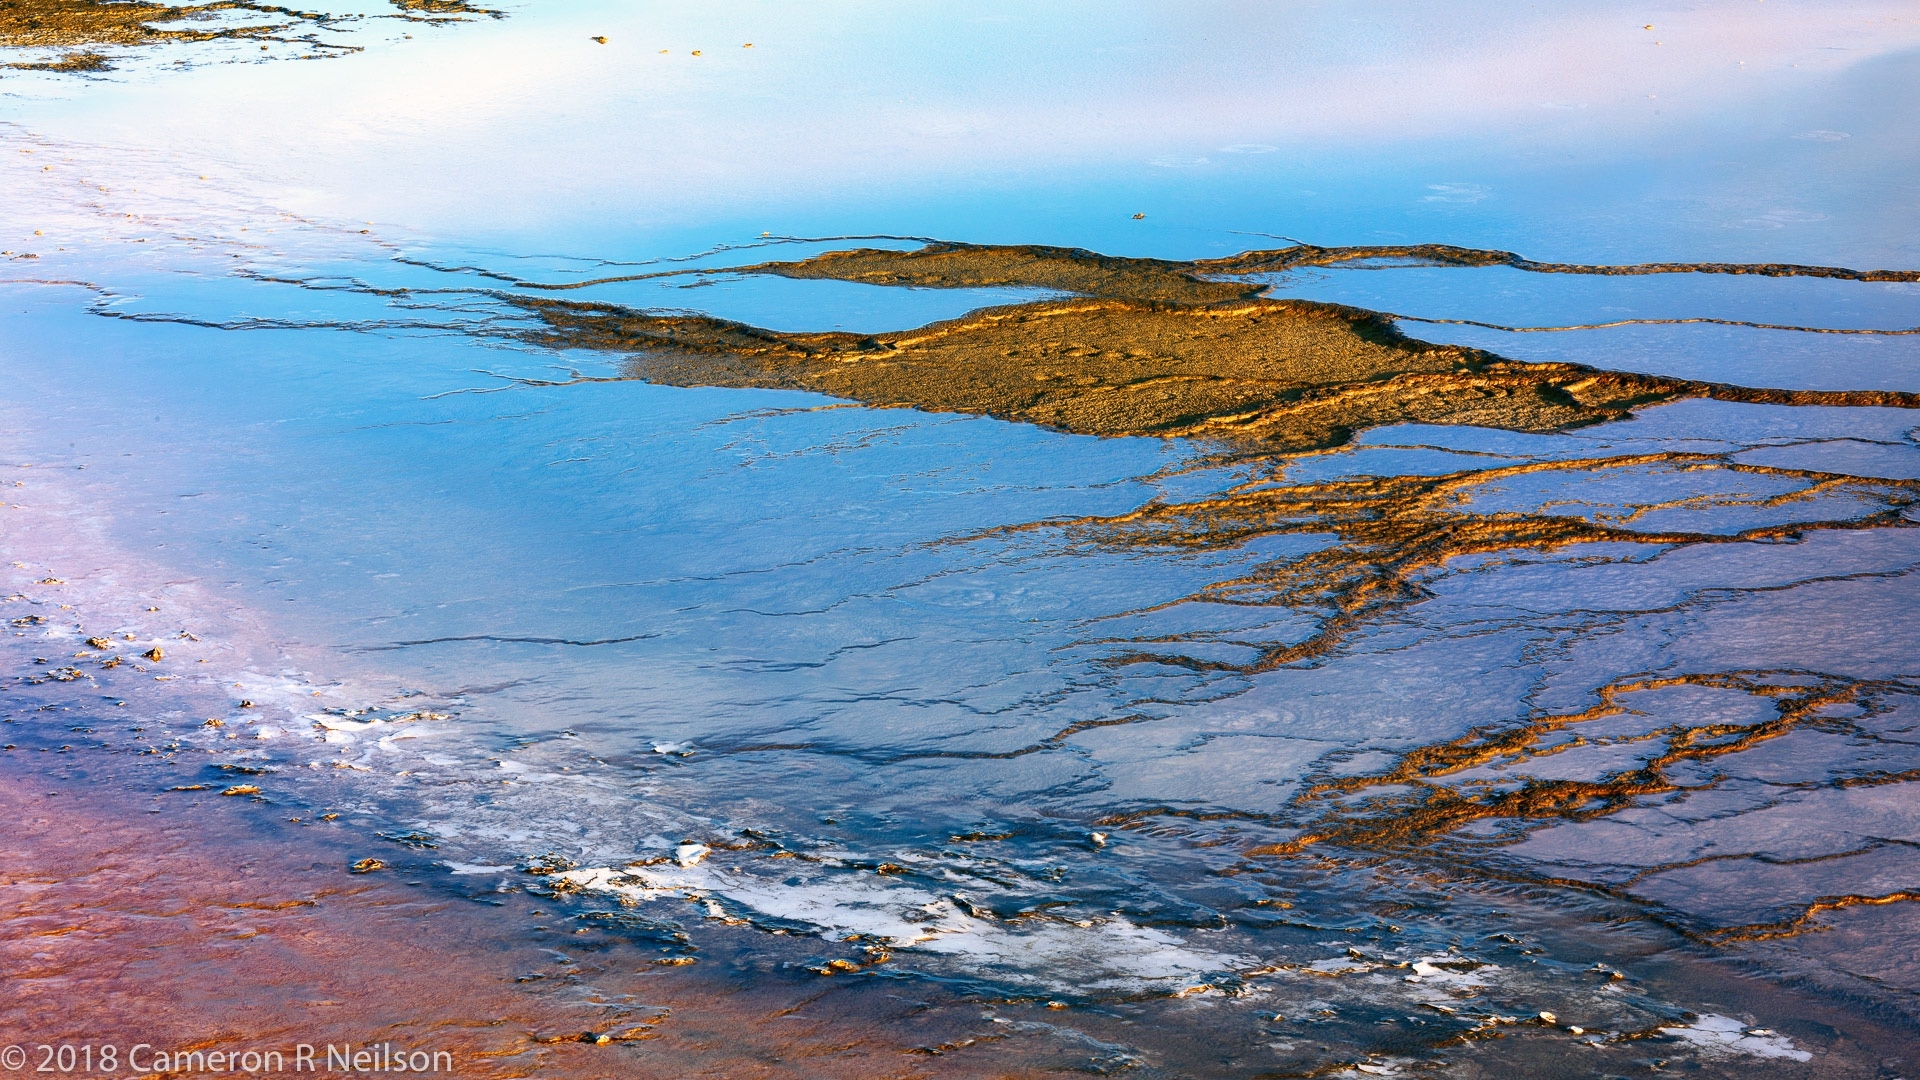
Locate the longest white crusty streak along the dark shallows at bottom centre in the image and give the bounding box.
[553,865,1252,990]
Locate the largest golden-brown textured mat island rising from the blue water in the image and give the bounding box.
[516,244,1920,454]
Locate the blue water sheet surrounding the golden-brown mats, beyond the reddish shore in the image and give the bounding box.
[0,4,1920,1076]
